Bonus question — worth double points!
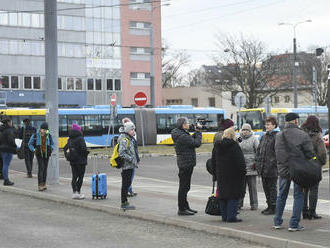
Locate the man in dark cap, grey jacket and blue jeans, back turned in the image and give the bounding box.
[274,113,314,232]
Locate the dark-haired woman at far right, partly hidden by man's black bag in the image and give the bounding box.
[301,115,327,219]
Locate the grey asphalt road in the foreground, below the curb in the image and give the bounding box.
[0,192,261,248]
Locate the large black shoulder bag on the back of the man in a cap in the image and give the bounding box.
[283,132,322,188]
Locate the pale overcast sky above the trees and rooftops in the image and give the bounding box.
[162,0,330,69]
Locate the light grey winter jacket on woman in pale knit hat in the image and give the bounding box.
[239,132,259,176]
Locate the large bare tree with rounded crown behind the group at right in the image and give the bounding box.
[208,35,277,108]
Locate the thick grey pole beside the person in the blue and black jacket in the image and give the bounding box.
[44,0,59,184]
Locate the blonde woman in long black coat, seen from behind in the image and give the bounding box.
[212,127,246,222]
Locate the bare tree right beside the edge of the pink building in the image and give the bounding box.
[162,42,190,88]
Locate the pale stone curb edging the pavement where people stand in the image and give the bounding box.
[0,184,325,248]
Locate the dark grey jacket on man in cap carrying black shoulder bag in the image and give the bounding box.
[275,123,314,179]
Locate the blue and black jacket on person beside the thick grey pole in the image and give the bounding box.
[29,130,54,158]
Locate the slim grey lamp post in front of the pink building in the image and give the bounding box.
[150,1,155,108]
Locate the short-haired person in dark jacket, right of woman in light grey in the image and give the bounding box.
[257,116,278,215]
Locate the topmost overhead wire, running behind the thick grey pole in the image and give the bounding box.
[0,0,170,14]
